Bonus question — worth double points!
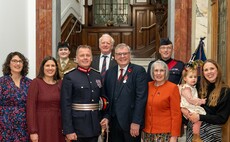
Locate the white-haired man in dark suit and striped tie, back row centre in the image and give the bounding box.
[91,34,117,78]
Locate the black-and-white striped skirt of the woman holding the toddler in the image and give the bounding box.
[186,121,222,142]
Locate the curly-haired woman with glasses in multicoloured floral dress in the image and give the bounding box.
[0,52,31,142]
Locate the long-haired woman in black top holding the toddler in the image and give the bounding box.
[182,59,230,142]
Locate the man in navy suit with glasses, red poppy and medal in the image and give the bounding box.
[101,43,148,142]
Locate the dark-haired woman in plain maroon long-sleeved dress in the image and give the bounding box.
[27,56,64,142]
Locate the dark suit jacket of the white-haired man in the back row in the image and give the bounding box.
[91,55,117,71]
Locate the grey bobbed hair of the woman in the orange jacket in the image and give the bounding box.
[150,60,169,80]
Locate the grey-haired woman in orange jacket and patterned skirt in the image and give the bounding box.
[143,60,182,142]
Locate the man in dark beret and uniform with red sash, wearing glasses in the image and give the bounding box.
[147,38,184,84]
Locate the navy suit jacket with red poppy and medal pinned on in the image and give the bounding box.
[104,63,148,132]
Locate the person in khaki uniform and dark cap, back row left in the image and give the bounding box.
[57,42,77,79]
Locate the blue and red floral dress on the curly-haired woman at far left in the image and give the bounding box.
[0,75,31,142]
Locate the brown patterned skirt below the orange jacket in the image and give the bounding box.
[142,132,171,142]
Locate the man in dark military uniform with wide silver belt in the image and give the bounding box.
[61,45,104,142]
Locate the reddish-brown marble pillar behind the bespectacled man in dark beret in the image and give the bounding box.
[174,0,192,62]
